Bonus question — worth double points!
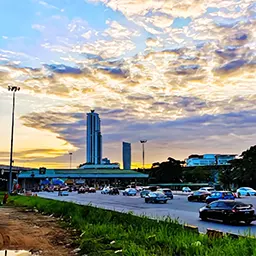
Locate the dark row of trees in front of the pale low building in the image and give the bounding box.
[139,145,256,189]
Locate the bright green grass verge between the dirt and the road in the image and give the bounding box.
[6,196,256,256]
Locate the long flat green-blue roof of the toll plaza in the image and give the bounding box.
[18,169,148,179]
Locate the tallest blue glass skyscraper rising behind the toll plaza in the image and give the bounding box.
[86,110,102,164]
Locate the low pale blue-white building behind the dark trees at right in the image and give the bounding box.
[186,154,236,166]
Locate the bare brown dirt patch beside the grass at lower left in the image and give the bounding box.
[0,207,77,256]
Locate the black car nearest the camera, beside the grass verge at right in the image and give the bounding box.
[199,200,256,224]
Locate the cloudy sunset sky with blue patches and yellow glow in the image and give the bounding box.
[0,0,256,168]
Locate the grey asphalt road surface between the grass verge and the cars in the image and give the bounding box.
[38,191,256,236]
